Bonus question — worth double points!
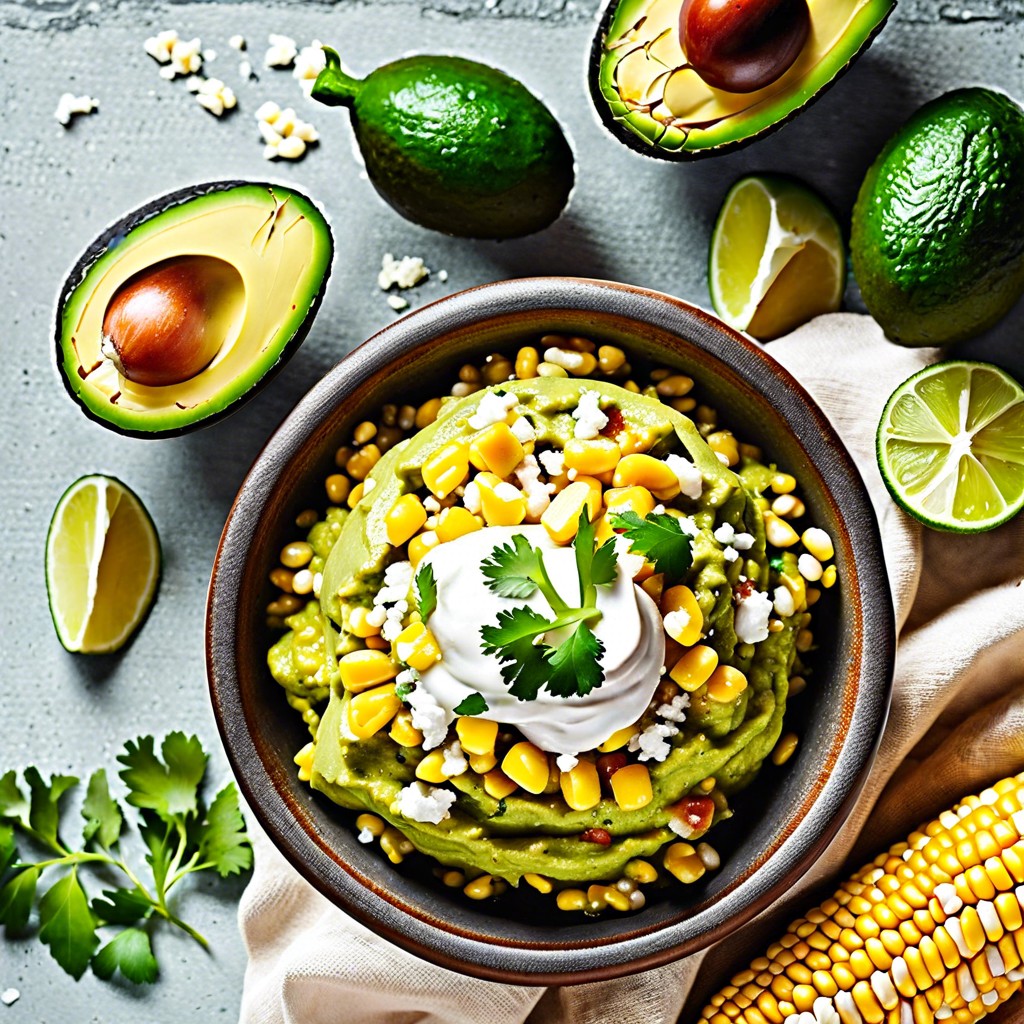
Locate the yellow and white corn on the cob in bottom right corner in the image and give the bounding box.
[700,773,1024,1024]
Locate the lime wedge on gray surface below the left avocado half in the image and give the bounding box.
[46,474,161,654]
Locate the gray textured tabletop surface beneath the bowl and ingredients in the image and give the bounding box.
[0,0,1024,1024]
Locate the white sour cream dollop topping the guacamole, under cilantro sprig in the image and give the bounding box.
[418,526,665,754]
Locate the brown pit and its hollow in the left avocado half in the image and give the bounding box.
[100,256,245,387]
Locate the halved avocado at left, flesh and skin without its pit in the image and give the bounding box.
[56,181,334,437]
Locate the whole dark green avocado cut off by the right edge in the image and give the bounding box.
[850,88,1024,346]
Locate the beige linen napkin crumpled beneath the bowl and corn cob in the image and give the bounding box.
[234,313,1024,1024]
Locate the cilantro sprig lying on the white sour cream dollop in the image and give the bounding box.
[480,509,616,700]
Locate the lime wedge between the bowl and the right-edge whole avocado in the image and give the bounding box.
[708,174,846,341]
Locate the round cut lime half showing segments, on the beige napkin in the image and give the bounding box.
[877,360,1024,534]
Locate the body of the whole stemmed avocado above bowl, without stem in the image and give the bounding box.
[352,56,573,239]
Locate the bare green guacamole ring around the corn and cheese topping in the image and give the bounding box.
[299,378,797,883]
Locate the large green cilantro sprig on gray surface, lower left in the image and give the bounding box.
[0,732,252,983]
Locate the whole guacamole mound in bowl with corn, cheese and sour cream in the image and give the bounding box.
[269,360,820,905]
